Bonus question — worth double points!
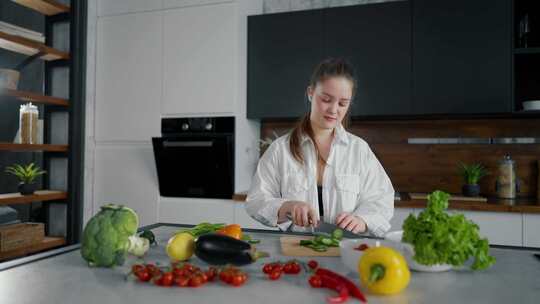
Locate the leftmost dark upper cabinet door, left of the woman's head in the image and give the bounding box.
[247,10,323,118]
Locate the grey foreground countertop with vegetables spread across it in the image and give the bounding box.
[0,226,540,304]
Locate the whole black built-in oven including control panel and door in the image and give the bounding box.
[152,117,234,199]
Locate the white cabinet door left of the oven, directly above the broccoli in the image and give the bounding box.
[93,144,159,226]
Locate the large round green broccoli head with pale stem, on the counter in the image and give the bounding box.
[81,204,149,267]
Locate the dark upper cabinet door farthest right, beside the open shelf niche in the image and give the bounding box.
[413,0,512,114]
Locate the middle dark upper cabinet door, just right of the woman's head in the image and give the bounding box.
[325,1,411,116]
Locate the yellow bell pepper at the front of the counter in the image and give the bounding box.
[358,246,411,295]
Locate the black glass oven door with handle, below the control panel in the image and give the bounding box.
[152,134,234,199]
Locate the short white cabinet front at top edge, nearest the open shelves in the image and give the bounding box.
[97,0,163,16]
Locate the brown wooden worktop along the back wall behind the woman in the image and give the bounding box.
[232,192,540,213]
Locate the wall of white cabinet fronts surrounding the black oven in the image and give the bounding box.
[84,0,262,226]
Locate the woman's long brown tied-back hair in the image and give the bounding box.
[289,58,356,164]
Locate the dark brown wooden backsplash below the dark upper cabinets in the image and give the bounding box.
[261,119,540,197]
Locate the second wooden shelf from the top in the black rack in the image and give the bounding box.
[0,31,69,61]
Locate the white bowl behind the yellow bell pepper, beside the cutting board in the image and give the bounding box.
[339,238,401,273]
